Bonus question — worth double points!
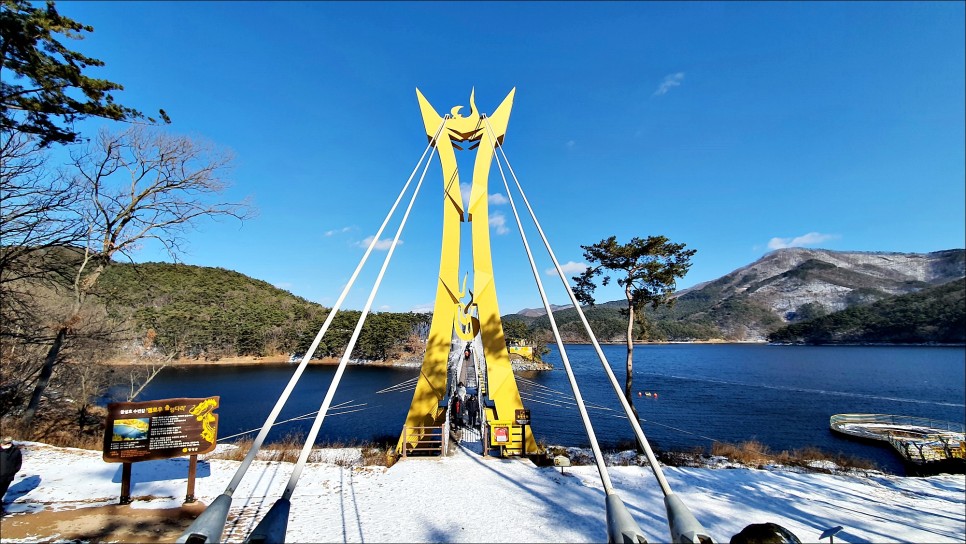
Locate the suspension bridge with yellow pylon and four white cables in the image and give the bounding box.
[177,89,713,544]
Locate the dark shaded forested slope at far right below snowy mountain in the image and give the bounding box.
[768,279,966,344]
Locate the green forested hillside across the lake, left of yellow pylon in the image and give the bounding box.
[97,263,428,359]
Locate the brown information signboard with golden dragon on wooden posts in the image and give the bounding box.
[103,397,221,463]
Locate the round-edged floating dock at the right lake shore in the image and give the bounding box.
[829,414,966,472]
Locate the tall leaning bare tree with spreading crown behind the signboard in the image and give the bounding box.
[24,125,252,425]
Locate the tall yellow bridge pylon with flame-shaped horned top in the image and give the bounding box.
[397,88,537,453]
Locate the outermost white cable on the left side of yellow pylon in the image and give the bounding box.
[224,116,448,497]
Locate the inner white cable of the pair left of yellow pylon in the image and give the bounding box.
[282,116,448,500]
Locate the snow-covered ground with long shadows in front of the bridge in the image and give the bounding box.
[3,442,966,542]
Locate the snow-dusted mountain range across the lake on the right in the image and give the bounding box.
[504,248,966,341]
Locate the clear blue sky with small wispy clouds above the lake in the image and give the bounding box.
[58,2,966,313]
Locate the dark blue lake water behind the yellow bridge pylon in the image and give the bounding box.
[138,344,966,473]
